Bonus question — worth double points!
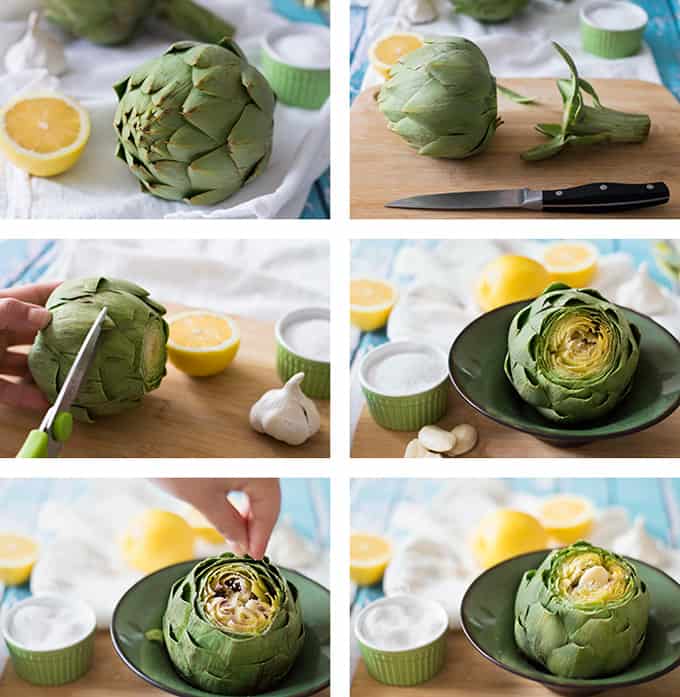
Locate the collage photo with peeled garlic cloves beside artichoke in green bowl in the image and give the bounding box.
[350,239,680,458]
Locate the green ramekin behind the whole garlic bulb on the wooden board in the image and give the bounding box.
[274,307,331,399]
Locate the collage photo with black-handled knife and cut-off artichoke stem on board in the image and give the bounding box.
[349,0,680,219]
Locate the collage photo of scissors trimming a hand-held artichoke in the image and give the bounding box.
[0,239,331,459]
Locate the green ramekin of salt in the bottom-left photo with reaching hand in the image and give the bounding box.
[2,594,97,687]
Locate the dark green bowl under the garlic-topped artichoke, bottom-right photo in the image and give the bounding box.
[461,551,680,696]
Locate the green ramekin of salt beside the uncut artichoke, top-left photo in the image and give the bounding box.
[262,23,331,109]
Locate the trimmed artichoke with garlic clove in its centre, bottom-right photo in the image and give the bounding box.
[515,542,649,678]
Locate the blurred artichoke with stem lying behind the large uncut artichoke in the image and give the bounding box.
[43,0,235,46]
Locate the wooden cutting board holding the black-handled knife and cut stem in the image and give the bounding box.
[351,79,680,218]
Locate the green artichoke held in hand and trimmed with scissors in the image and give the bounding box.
[28,278,168,421]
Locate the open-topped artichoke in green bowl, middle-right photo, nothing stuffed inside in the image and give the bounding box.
[505,283,640,424]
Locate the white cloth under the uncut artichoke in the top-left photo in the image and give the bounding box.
[0,0,330,218]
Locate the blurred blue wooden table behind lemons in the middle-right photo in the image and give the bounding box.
[350,240,670,363]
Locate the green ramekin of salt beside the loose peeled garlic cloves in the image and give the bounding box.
[359,341,449,431]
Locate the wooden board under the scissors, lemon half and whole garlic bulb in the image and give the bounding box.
[0,306,330,458]
